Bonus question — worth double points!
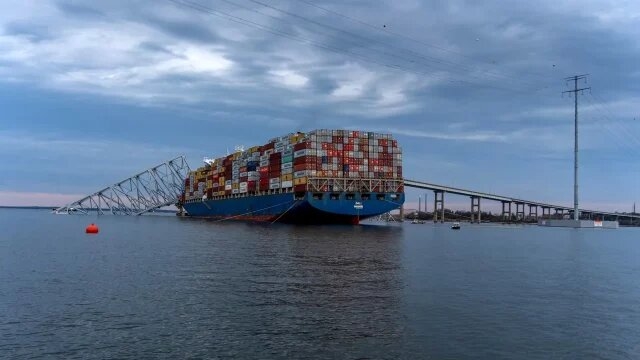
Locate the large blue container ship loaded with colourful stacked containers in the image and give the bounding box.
[178,129,405,224]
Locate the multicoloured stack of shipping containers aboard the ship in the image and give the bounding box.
[185,129,402,200]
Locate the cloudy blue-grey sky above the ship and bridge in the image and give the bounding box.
[0,0,640,211]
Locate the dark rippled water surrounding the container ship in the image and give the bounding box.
[0,209,640,359]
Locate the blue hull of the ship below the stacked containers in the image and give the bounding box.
[183,192,404,224]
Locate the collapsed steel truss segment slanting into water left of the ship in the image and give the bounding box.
[55,156,190,215]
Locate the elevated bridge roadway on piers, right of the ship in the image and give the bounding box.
[404,179,640,222]
